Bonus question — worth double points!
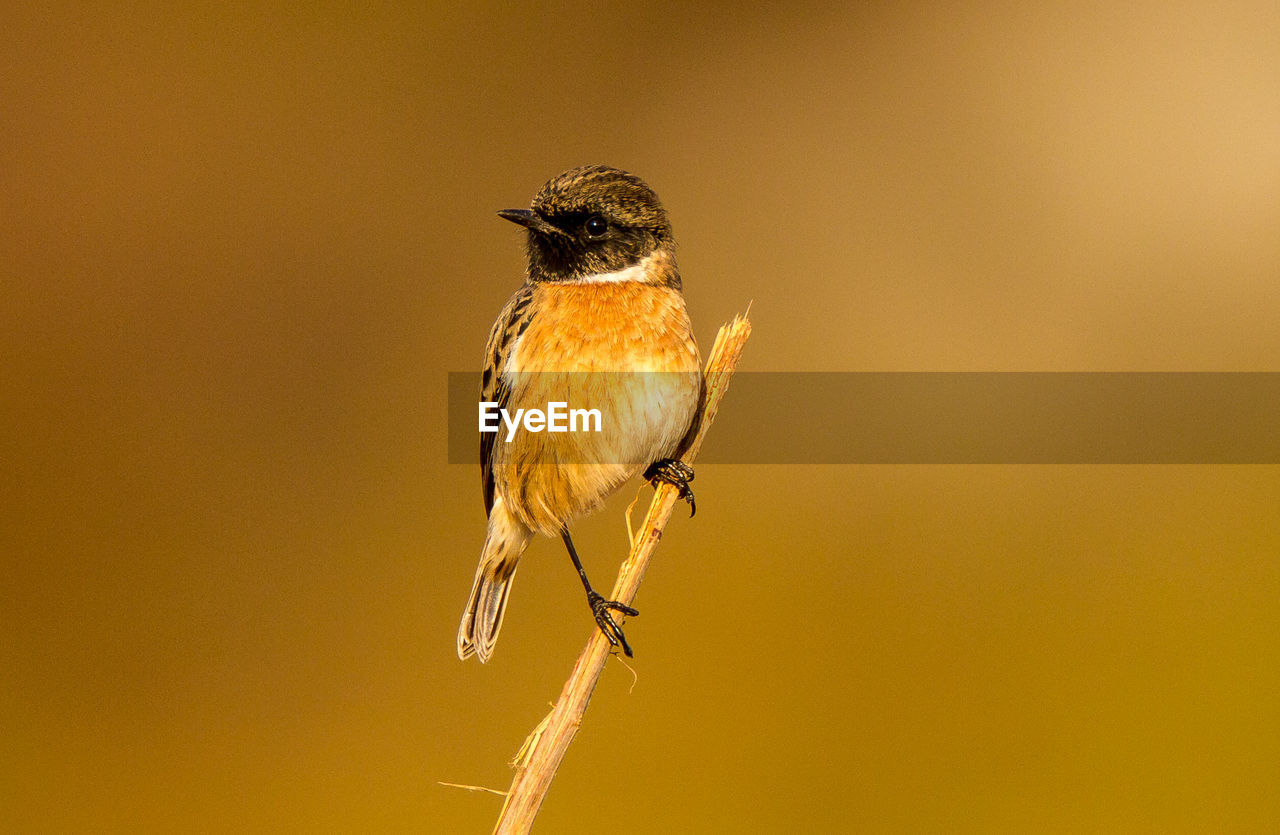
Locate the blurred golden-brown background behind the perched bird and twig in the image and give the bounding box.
[0,3,1280,832]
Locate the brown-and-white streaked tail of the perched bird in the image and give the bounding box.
[458,497,532,663]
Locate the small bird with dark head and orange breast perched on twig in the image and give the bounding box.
[457,165,705,662]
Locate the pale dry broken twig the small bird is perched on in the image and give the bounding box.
[494,306,751,835]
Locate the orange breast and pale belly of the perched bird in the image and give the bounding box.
[494,276,701,534]
